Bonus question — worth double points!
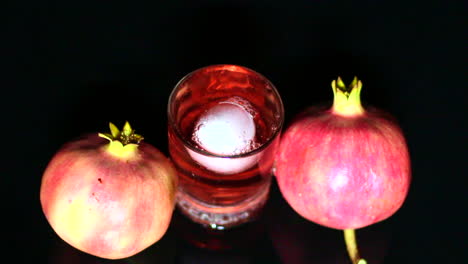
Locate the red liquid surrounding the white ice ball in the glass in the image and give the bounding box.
[168,64,282,229]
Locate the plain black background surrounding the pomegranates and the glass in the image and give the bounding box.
[5,0,467,264]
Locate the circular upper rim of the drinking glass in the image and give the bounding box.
[167,64,284,159]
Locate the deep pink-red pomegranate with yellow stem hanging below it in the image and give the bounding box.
[275,78,411,263]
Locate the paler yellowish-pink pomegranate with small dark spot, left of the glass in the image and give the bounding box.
[40,122,177,259]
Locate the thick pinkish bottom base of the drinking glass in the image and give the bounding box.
[177,186,270,230]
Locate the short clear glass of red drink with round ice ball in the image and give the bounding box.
[168,65,284,229]
